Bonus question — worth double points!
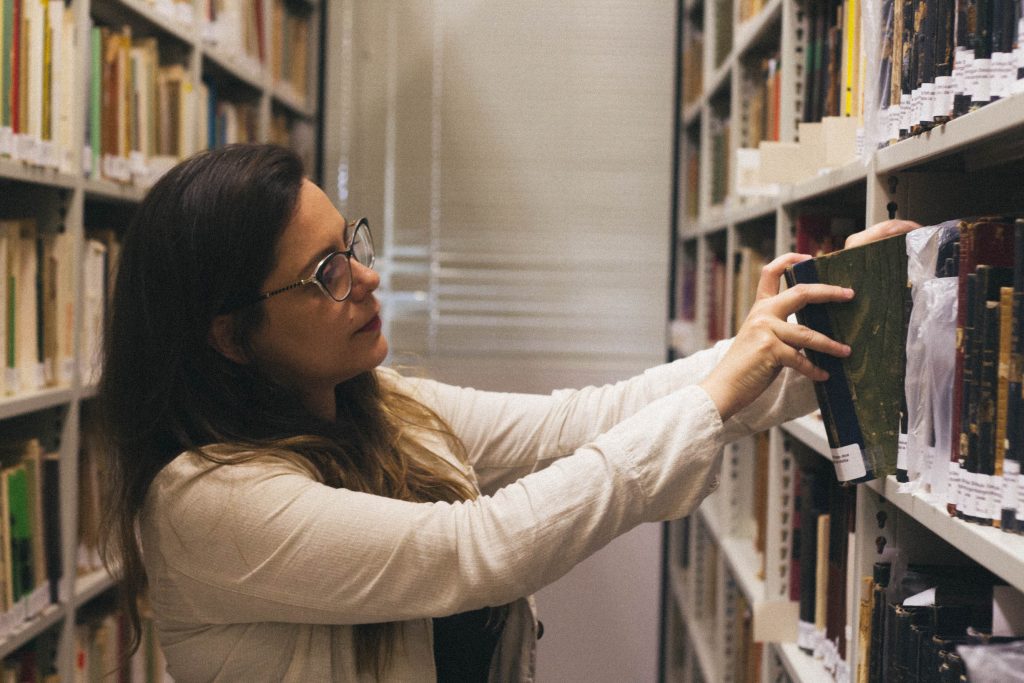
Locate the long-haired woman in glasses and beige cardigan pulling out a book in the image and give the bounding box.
[99,145,913,682]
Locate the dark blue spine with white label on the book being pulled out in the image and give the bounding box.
[785,260,874,483]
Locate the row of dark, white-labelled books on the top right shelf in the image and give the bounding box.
[879,0,1024,143]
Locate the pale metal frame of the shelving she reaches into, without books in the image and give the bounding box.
[663,0,1024,683]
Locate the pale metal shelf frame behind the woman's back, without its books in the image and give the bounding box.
[0,0,326,680]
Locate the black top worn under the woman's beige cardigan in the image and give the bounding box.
[434,607,505,683]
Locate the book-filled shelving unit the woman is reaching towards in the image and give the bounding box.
[663,0,1024,683]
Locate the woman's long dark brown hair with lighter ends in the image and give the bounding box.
[98,144,476,676]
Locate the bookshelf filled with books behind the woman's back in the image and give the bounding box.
[0,0,326,681]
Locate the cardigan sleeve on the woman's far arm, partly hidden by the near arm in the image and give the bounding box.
[390,340,816,493]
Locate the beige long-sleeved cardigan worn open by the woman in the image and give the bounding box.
[141,342,815,683]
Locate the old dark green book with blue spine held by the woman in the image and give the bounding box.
[785,236,909,482]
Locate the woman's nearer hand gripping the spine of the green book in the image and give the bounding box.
[700,254,854,421]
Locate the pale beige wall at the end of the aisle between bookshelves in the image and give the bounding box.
[325,0,676,683]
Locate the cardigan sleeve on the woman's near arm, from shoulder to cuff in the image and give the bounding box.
[141,387,723,625]
